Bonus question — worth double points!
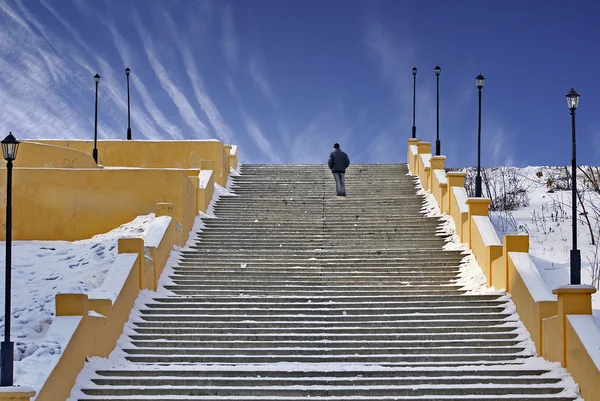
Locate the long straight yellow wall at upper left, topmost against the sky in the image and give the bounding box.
[30,139,232,186]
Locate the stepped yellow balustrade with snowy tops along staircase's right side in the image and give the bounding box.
[407,139,600,401]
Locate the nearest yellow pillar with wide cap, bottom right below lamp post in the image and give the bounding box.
[552,285,596,368]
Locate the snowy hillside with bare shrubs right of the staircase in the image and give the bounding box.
[466,167,600,323]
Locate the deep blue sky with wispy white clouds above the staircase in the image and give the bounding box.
[0,0,600,167]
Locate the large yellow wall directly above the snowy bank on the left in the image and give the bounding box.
[0,168,197,245]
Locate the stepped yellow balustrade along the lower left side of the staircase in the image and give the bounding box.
[27,204,189,401]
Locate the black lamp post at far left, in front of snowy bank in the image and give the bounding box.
[0,132,20,386]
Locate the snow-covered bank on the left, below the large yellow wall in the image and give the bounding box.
[0,213,154,360]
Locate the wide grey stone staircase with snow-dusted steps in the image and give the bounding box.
[71,165,577,401]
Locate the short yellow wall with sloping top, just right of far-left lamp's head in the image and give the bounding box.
[15,141,99,168]
